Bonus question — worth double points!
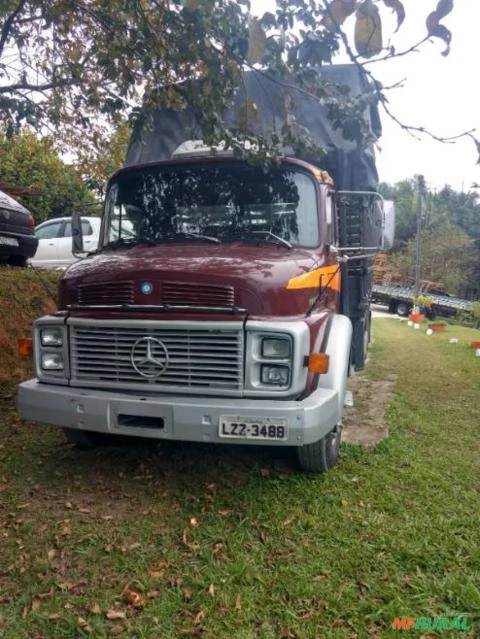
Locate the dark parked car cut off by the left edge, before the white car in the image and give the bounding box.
[0,191,38,266]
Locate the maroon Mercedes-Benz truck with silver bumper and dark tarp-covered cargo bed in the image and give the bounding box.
[17,65,383,472]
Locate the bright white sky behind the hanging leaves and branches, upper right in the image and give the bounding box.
[252,0,480,191]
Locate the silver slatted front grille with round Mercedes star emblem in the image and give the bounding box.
[69,319,244,394]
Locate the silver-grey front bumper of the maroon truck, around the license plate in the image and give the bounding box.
[17,379,339,446]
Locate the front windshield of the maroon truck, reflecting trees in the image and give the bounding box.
[104,162,319,247]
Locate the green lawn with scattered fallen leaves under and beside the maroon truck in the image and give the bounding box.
[0,320,480,639]
